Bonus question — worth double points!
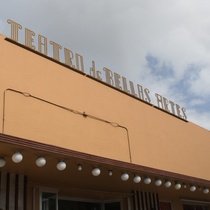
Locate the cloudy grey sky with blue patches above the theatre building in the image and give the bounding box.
[0,0,210,130]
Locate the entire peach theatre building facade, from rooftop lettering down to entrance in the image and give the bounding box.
[0,25,210,210]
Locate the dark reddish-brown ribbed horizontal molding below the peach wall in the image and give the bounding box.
[0,133,210,186]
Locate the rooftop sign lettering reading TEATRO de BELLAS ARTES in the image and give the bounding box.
[7,20,187,120]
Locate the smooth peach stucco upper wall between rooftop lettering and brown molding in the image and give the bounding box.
[0,35,210,179]
